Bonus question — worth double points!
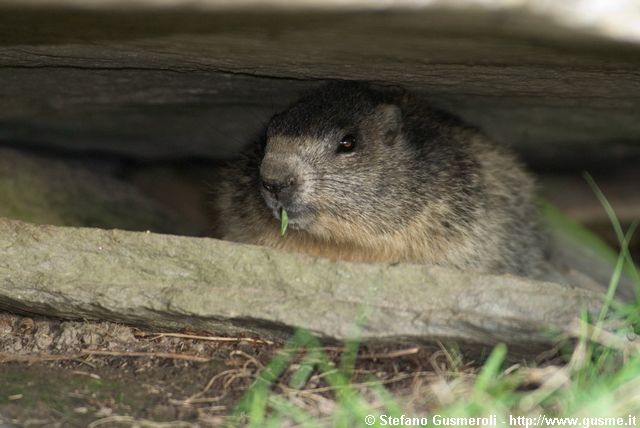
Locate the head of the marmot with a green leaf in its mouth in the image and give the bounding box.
[260,83,456,242]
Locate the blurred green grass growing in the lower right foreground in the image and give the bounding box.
[228,176,640,427]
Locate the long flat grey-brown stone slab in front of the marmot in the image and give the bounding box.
[0,220,600,347]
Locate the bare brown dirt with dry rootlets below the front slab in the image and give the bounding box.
[0,313,474,428]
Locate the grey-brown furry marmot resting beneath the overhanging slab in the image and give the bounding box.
[214,82,544,276]
